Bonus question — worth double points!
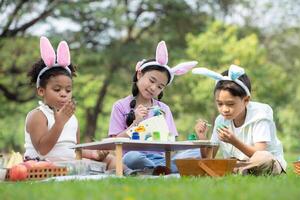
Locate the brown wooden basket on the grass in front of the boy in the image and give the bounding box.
[175,158,237,177]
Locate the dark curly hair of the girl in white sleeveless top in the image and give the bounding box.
[27,59,76,88]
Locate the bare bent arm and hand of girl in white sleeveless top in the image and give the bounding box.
[26,101,75,155]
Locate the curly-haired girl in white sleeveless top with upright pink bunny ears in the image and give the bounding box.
[24,37,122,169]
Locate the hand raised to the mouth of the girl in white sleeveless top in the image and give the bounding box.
[54,100,76,124]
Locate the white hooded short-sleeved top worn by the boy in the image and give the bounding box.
[211,102,287,170]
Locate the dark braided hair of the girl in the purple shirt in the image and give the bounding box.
[126,59,171,126]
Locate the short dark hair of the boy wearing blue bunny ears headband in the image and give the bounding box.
[214,70,251,98]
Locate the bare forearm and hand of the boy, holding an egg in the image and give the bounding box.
[218,128,267,157]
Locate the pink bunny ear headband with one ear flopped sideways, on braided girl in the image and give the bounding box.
[136,41,198,85]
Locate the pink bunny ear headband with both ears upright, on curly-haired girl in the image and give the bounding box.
[36,36,72,88]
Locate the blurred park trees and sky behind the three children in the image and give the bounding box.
[0,0,300,153]
